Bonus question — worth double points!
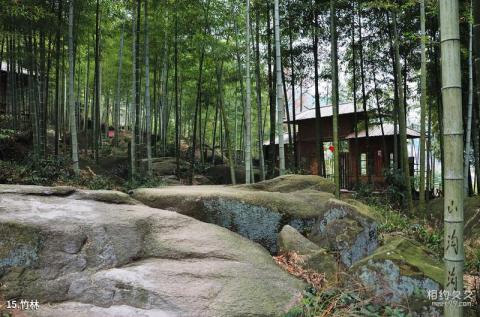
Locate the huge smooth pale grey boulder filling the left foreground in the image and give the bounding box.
[0,186,305,317]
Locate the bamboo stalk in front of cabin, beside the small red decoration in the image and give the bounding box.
[330,0,340,198]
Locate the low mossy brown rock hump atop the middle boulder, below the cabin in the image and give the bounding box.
[238,174,335,194]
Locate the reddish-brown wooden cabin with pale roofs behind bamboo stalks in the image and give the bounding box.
[264,103,419,190]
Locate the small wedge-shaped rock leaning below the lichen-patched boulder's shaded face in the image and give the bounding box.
[278,225,337,280]
